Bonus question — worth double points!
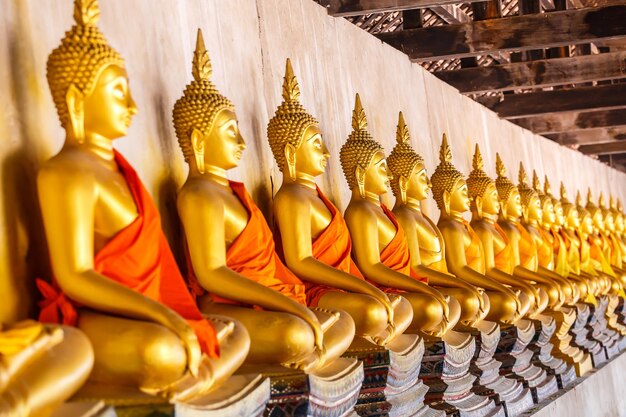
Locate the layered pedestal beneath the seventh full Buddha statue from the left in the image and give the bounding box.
[529,315,576,389]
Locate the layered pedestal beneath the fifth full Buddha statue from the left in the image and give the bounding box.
[470,321,534,417]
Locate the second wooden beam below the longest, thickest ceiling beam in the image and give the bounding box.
[488,83,626,119]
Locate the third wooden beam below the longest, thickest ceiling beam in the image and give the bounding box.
[512,109,626,135]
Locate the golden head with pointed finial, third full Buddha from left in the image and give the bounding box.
[267,59,330,180]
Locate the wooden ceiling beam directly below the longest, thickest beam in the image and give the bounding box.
[435,51,626,93]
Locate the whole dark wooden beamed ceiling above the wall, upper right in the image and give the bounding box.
[316,0,626,171]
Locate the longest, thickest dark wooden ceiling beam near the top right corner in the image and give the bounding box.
[377,5,626,61]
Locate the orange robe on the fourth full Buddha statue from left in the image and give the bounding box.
[375,204,428,293]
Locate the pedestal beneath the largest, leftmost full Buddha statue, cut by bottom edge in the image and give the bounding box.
[67,374,270,417]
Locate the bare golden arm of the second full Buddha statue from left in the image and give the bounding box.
[178,187,323,349]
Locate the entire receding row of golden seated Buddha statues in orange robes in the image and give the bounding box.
[0,0,626,416]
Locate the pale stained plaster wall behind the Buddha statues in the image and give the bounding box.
[0,0,626,322]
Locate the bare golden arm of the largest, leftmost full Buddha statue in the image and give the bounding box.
[37,163,201,374]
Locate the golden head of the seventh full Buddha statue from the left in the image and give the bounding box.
[467,144,500,218]
